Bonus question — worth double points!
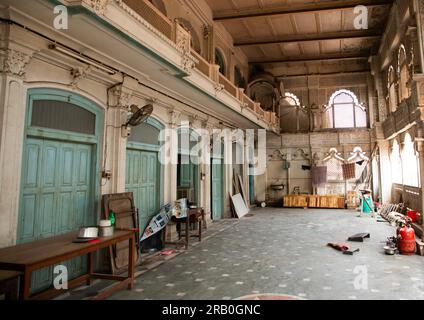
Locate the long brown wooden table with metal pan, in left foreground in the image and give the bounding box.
[0,230,135,300]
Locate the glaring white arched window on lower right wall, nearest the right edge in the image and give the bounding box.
[402,133,420,187]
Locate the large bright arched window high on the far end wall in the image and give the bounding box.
[326,89,367,128]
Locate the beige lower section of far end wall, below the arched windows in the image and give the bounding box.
[257,129,371,201]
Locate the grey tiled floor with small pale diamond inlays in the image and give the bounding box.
[110,208,424,300]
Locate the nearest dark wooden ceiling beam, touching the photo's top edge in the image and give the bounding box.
[213,0,394,21]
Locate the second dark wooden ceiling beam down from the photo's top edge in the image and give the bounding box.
[234,29,384,47]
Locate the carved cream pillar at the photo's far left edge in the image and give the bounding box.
[0,45,32,247]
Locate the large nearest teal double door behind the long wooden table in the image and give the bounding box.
[18,138,96,292]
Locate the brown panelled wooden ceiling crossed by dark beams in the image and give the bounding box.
[207,0,393,75]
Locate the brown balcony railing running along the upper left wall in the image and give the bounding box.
[123,0,279,127]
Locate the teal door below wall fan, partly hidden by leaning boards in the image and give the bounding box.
[126,149,160,231]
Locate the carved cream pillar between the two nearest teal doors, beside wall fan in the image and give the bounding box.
[102,78,138,193]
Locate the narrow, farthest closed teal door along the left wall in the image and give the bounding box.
[211,159,224,220]
